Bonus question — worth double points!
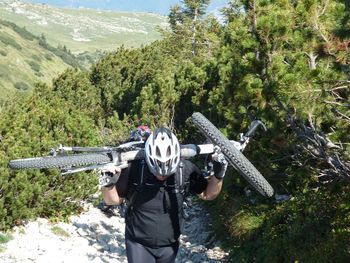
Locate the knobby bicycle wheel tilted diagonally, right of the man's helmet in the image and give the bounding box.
[192,112,273,197]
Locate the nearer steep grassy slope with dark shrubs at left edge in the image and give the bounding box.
[0,20,83,102]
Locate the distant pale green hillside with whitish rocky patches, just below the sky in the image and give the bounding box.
[0,0,167,53]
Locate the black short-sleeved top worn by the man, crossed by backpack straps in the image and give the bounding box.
[117,160,207,248]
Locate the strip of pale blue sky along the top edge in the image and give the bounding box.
[24,0,229,15]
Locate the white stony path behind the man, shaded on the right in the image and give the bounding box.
[0,199,228,263]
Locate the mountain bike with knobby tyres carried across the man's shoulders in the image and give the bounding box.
[9,112,274,197]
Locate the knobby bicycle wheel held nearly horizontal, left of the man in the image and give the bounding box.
[9,153,111,170]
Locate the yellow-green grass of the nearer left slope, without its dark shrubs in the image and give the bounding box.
[0,22,69,101]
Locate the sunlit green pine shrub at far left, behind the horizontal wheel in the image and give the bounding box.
[0,81,101,229]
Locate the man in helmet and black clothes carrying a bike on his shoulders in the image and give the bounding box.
[102,128,227,263]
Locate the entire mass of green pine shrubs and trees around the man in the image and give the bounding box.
[0,0,350,262]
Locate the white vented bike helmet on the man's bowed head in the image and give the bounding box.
[145,127,180,176]
